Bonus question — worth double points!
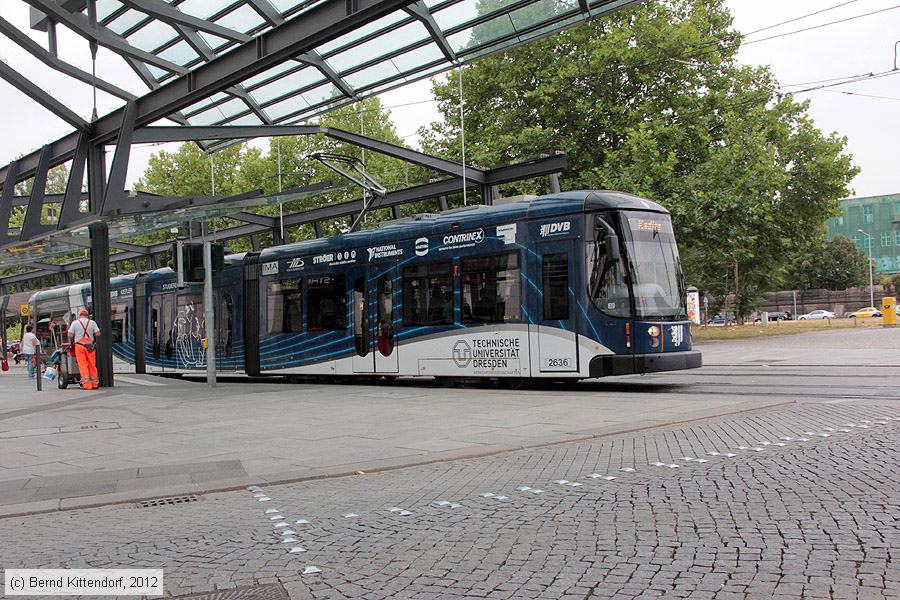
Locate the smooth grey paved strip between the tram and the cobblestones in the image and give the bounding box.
[0,329,900,516]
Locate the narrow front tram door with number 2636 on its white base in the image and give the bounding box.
[535,240,578,373]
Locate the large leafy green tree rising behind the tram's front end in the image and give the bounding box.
[421,0,857,315]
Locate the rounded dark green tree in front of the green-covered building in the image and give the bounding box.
[785,235,869,290]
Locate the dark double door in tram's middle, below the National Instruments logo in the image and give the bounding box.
[352,265,400,373]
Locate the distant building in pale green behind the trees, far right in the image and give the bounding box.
[827,194,900,275]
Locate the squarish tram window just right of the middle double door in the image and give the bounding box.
[403,261,453,326]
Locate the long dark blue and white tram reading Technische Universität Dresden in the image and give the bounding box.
[26,192,701,379]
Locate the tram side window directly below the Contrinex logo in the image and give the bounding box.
[462,253,522,323]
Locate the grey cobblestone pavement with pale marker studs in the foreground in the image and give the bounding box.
[0,403,900,600]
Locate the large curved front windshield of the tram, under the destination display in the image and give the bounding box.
[588,211,687,320]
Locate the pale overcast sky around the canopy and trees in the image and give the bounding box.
[0,0,900,196]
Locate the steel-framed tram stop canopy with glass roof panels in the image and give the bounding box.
[0,0,640,384]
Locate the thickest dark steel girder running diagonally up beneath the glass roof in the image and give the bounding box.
[0,0,413,189]
